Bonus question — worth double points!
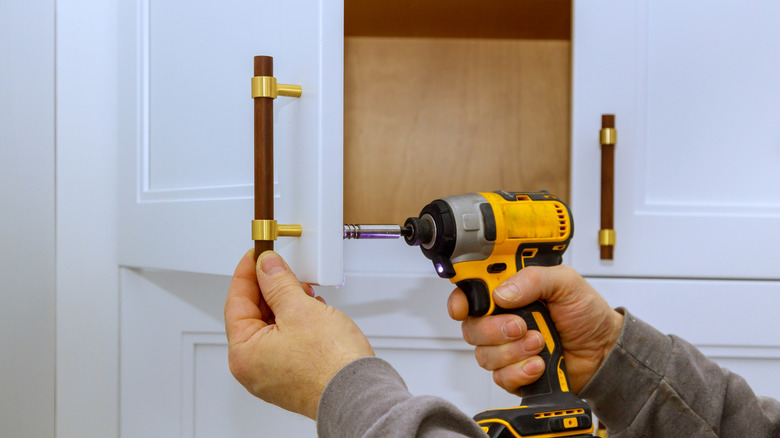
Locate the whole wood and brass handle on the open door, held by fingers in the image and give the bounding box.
[252,56,302,259]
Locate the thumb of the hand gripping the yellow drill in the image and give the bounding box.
[493,265,579,309]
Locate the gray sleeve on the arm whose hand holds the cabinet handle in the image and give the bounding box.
[317,357,485,438]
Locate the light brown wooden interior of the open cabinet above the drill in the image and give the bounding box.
[344,0,571,223]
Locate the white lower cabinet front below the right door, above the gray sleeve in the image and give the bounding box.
[588,278,780,399]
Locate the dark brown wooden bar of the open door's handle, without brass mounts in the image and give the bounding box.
[254,56,274,259]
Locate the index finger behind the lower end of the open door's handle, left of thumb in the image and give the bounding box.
[225,250,267,343]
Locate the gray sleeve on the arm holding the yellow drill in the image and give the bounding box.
[579,309,780,438]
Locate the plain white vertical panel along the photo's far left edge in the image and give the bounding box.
[0,0,56,438]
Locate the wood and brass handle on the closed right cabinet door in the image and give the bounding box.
[599,114,617,260]
